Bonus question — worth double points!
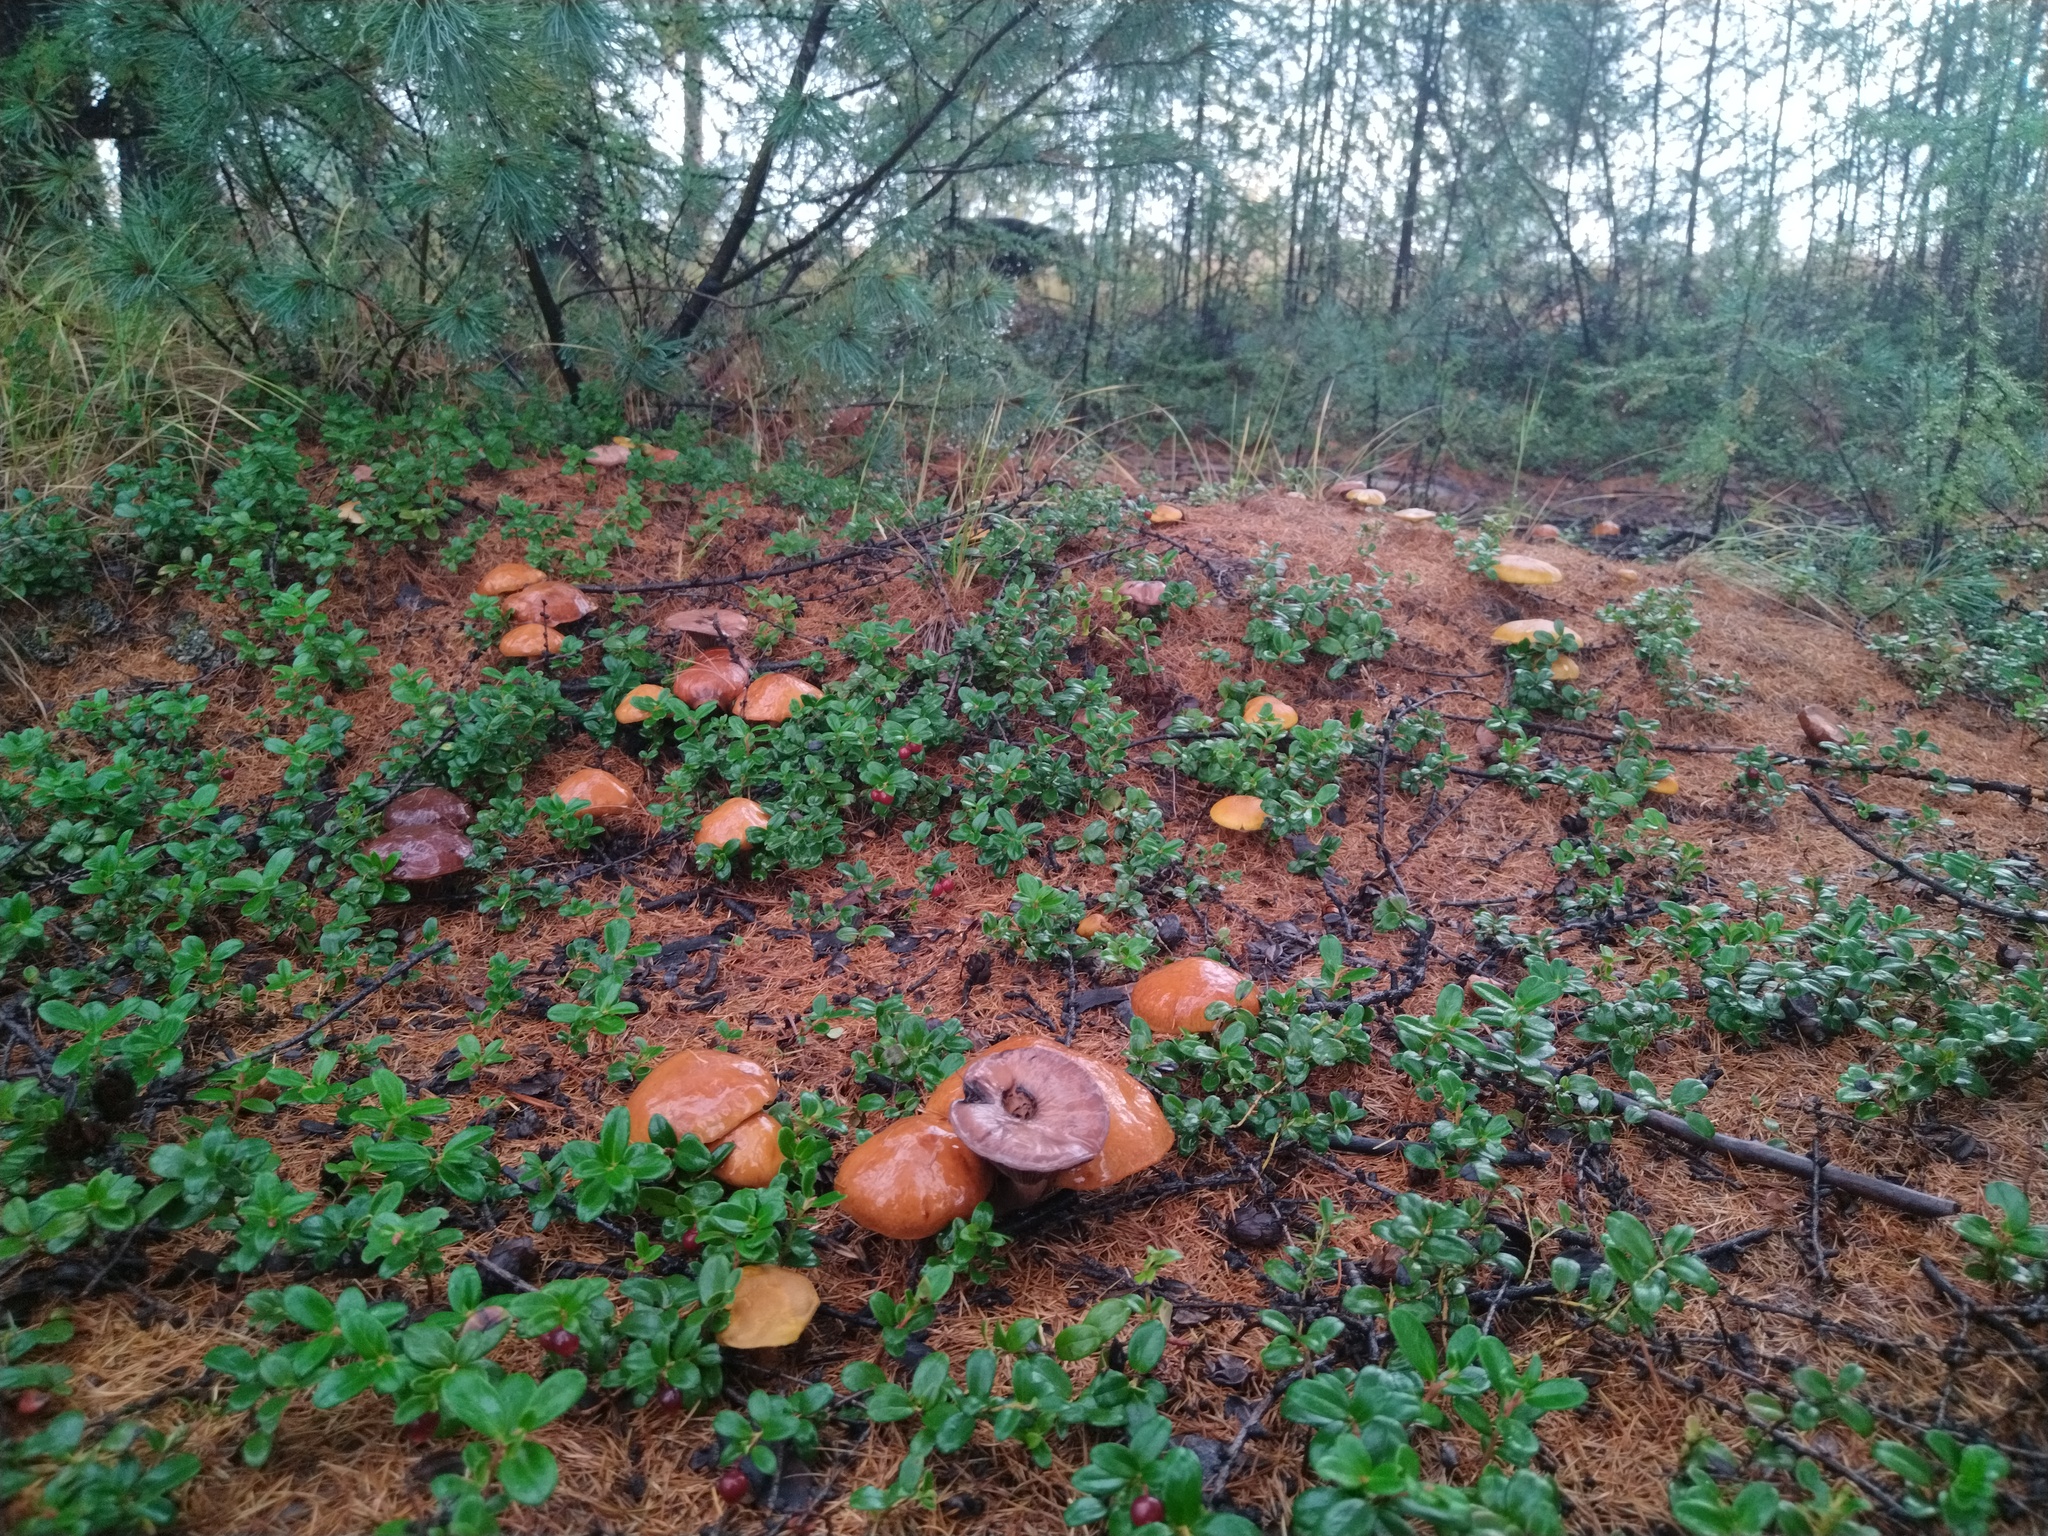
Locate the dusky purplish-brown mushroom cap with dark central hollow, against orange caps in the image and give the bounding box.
[946,1047,1110,1182]
